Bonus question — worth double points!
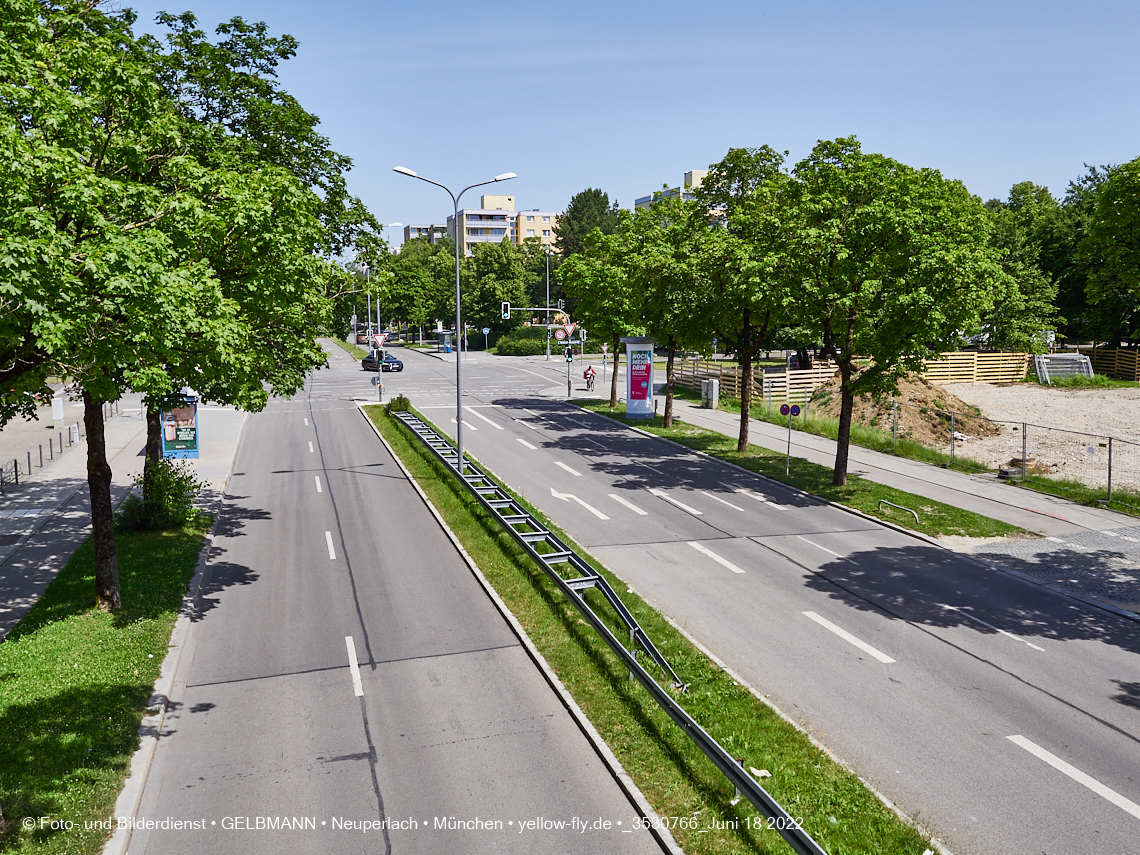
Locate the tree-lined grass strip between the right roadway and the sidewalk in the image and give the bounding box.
[580,402,1029,537]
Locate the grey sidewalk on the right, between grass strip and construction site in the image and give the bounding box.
[674,399,1140,617]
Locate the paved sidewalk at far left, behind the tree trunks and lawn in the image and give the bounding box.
[0,398,246,640]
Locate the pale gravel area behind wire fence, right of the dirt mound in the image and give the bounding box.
[942,383,1140,491]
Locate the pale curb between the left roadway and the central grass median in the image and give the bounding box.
[356,401,685,855]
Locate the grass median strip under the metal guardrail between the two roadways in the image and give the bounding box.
[365,406,929,855]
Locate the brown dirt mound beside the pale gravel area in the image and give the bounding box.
[809,375,1001,448]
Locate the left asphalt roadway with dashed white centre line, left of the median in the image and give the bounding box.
[129,352,661,855]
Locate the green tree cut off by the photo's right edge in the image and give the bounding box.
[1081,158,1140,347]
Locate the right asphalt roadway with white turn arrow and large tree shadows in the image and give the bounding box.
[394,353,1140,855]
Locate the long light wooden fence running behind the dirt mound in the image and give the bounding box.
[674,351,1030,404]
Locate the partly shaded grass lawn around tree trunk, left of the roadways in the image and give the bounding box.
[0,518,210,855]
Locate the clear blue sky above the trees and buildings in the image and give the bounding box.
[117,0,1140,243]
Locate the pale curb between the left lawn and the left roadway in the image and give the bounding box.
[103,413,250,855]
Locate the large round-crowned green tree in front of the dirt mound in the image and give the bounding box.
[780,137,1007,486]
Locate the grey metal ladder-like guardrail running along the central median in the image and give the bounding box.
[392,413,827,855]
